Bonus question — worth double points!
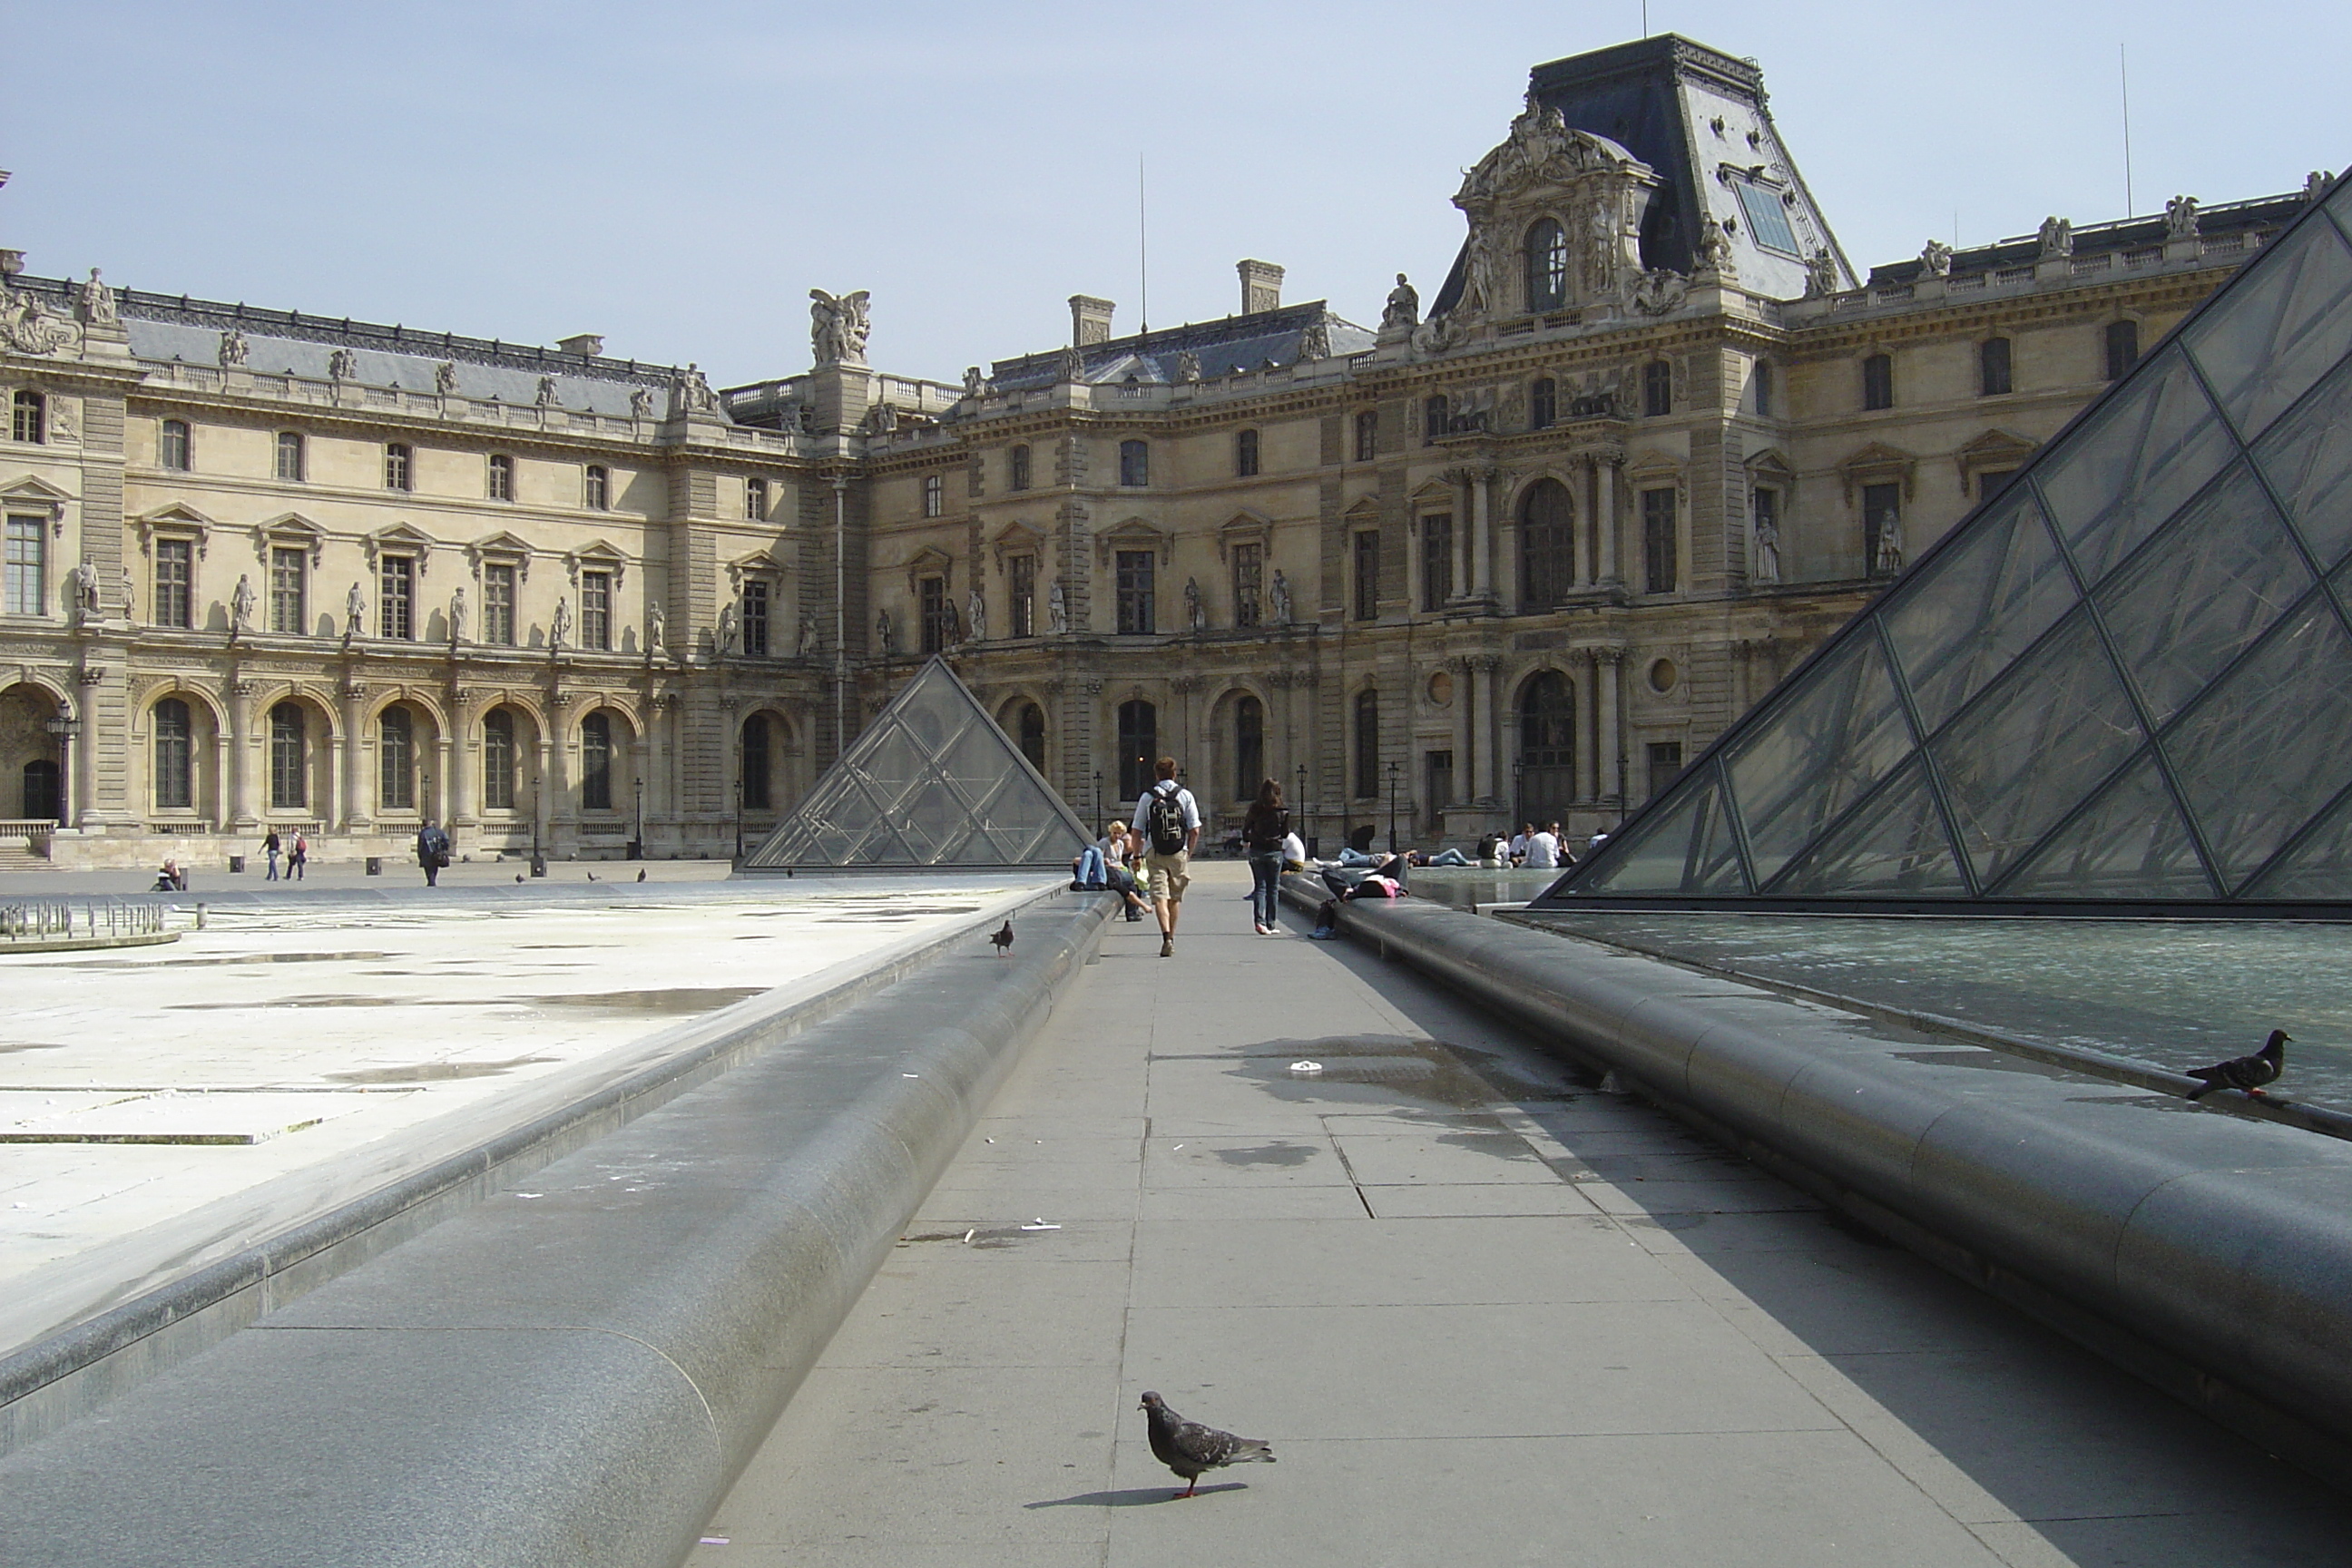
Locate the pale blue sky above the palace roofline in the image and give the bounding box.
[0,0,2352,386]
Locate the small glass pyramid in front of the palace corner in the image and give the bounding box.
[743,658,1087,872]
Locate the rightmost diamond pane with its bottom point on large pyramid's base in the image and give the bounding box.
[2164,593,2352,888]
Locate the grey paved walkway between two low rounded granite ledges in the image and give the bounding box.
[689,863,2352,1568]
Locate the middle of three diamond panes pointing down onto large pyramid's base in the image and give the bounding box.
[1931,612,2147,887]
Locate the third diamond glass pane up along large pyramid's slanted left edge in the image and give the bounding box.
[2037,348,2234,585]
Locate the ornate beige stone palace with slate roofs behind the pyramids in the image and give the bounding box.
[0,35,2326,865]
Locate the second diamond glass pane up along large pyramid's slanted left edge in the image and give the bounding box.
[1884,485,2074,733]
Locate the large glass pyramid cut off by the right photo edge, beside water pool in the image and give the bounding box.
[1536,166,2352,915]
